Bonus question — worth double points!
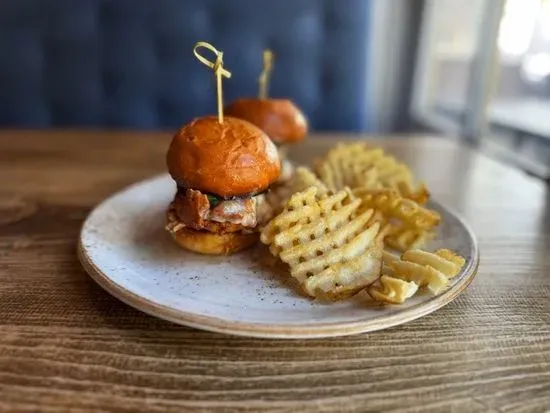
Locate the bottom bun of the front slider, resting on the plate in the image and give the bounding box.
[172,228,258,255]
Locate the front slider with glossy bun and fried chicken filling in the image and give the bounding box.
[166,116,280,255]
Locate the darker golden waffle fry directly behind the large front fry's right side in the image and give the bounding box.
[353,188,441,251]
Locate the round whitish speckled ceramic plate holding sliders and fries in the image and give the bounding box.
[79,175,479,338]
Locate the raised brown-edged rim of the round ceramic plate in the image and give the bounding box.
[77,180,479,339]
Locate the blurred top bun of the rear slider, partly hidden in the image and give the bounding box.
[224,99,308,144]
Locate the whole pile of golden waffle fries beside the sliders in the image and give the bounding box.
[261,143,465,304]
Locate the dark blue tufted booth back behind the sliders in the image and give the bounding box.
[0,0,371,130]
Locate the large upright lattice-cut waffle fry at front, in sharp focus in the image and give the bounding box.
[261,187,384,300]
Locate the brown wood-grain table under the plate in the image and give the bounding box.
[0,131,550,412]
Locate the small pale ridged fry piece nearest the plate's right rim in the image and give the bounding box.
[383,249,465,294]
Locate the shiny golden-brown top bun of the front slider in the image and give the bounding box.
[166,116,280,198]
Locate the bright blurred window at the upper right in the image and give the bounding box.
[411,0,550,177]
